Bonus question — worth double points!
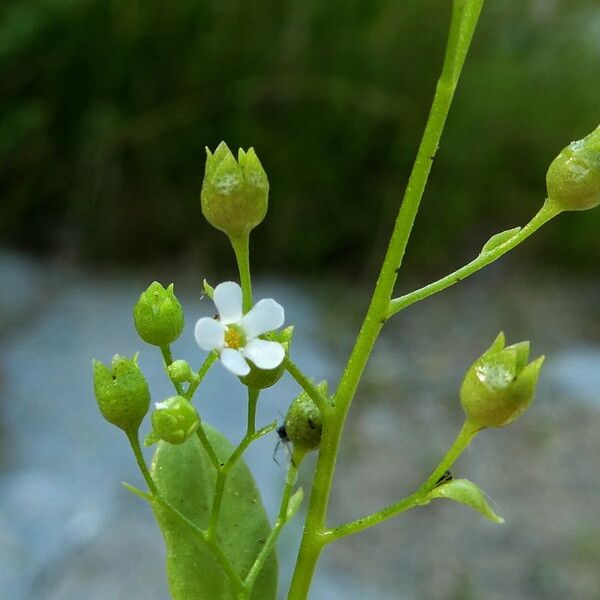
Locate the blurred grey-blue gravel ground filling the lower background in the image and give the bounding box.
[0,252,600,600]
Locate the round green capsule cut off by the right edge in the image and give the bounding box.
[546,127,600,210]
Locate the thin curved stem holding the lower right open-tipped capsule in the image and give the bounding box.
[327,422,479,542]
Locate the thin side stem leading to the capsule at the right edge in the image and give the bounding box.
[387,203,560,318]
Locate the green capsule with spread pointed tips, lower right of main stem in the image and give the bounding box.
[460,332,544,429]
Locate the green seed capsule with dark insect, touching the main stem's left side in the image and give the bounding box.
[284,381,328,452]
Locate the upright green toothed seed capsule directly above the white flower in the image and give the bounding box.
[200,142,269,238]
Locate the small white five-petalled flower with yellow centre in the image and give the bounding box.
[194,281,285,376]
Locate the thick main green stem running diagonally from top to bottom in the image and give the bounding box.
[288,0,483,600]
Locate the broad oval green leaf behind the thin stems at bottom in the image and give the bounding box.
[152,423,278,600]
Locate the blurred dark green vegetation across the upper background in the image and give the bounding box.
[0,0,600,272]
